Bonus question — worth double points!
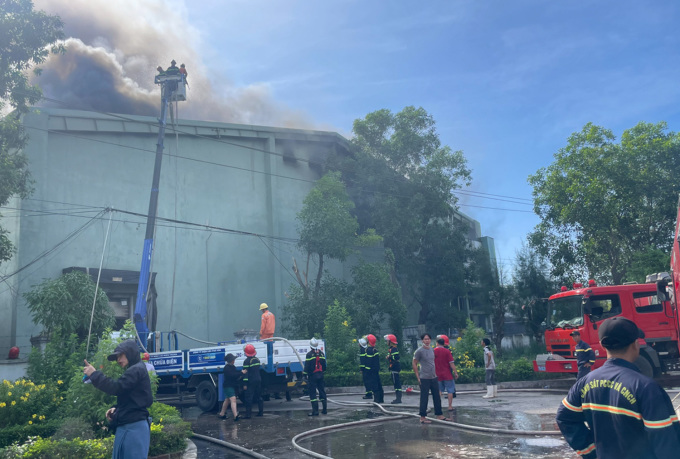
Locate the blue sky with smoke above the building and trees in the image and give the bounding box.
[30,0,680,272]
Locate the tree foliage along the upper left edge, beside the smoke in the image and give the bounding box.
[0,0,64,263]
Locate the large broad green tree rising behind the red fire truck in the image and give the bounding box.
[529,122,680,284]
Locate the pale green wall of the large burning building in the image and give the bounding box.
[0,109,347,355]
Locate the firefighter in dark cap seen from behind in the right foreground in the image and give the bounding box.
[556,316,680,459]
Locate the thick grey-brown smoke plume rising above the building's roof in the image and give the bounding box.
[33,0,313,128]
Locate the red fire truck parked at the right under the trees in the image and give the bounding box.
[534,199,680,377]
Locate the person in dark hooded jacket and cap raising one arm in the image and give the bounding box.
[83,340,153,459]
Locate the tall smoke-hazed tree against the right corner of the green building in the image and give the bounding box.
[329,106,470,323]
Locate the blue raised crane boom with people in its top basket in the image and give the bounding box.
[134,67,186,347]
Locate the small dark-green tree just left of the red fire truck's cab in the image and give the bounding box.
[511,245,557,342]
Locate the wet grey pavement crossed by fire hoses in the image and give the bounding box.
[171,391,577,459]
